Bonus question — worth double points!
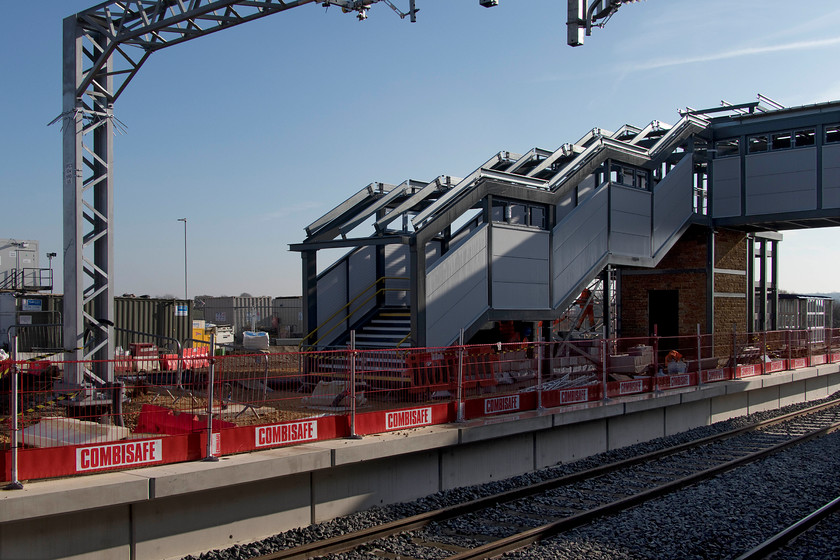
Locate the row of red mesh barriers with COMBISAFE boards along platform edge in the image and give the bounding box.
[0,332,840,486]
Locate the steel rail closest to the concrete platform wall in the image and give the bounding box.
[251,399,840,560]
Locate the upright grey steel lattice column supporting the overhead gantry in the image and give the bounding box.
[62,16,114,385]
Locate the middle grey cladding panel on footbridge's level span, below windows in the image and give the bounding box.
[746,148,817,215]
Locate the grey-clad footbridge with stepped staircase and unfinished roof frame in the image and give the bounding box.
[291,97,840,346]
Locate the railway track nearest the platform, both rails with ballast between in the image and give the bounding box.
[246,401,840,560]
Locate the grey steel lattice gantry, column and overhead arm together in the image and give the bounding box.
[56,0,626,385]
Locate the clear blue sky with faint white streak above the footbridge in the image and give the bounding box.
[0,0,840,296]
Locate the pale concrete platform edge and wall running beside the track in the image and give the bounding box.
[0,364,840,560]
